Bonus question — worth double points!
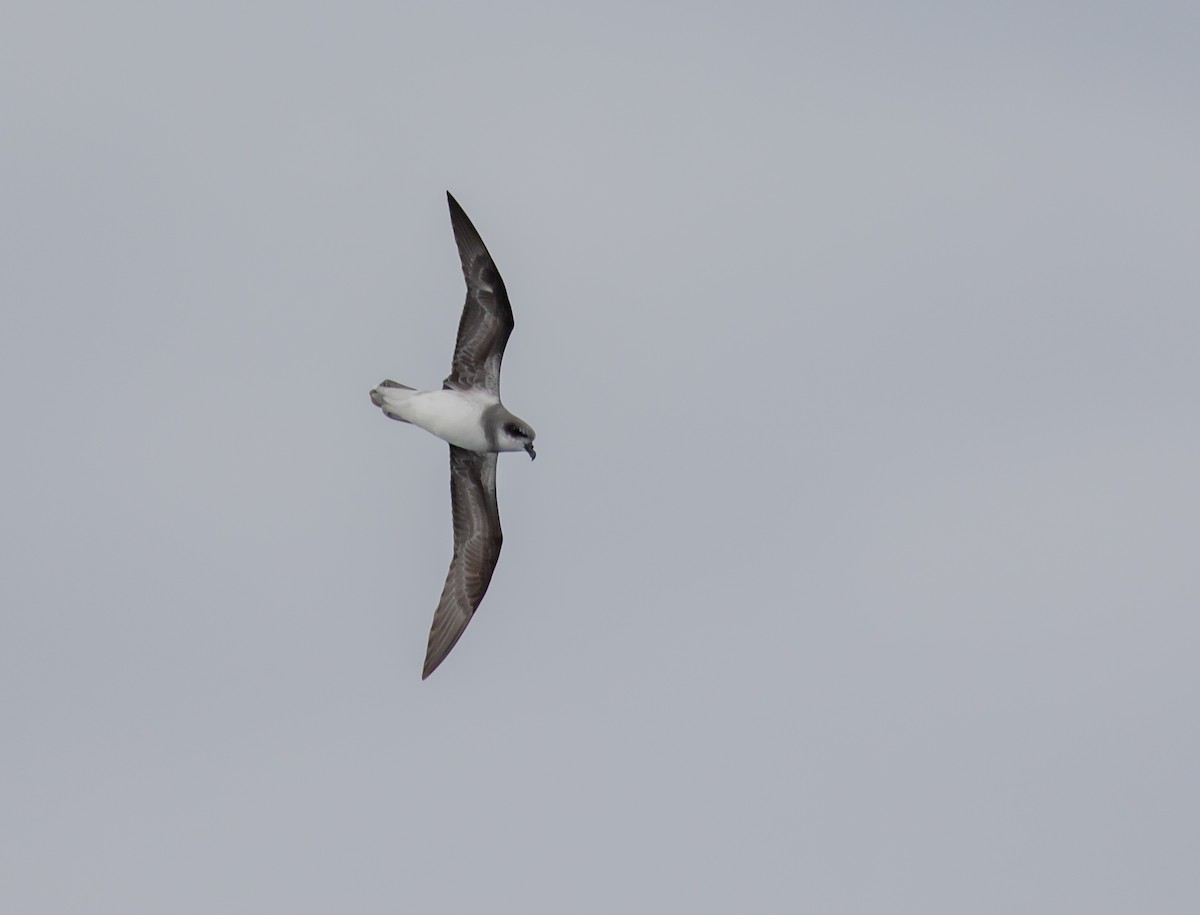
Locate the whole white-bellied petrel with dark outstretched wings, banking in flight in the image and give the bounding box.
[371,191,538,680]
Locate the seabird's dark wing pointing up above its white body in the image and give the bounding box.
[443,191,512,395]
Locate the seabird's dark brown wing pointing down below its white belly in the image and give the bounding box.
[421,445,504,680]
